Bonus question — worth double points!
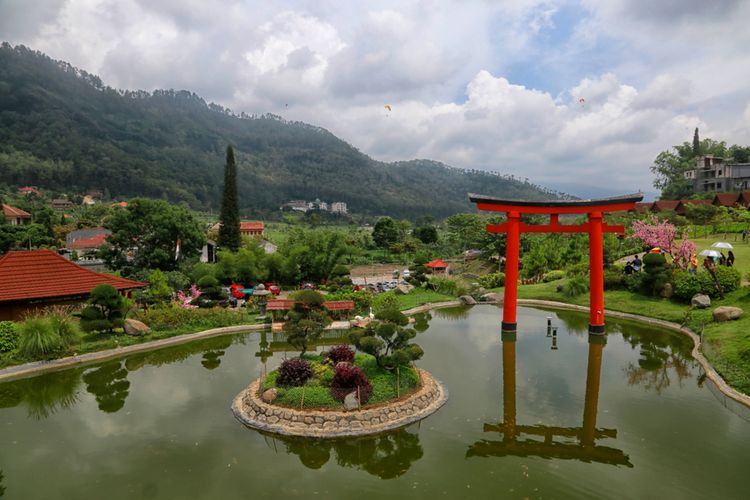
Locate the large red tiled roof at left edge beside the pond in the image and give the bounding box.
[0,250,146,302]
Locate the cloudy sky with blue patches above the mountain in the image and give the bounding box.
[0,0,750,195]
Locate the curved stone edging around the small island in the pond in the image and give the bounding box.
[232,368,448,438]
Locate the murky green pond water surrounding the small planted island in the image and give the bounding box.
[0,306,750,500]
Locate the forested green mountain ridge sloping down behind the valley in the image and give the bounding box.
[0,43,554,218]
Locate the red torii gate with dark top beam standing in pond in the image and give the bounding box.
[469,193,643,335]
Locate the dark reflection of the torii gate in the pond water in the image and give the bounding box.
[466,333,633,467]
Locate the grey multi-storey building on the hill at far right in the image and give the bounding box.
[684,155,750,193]
